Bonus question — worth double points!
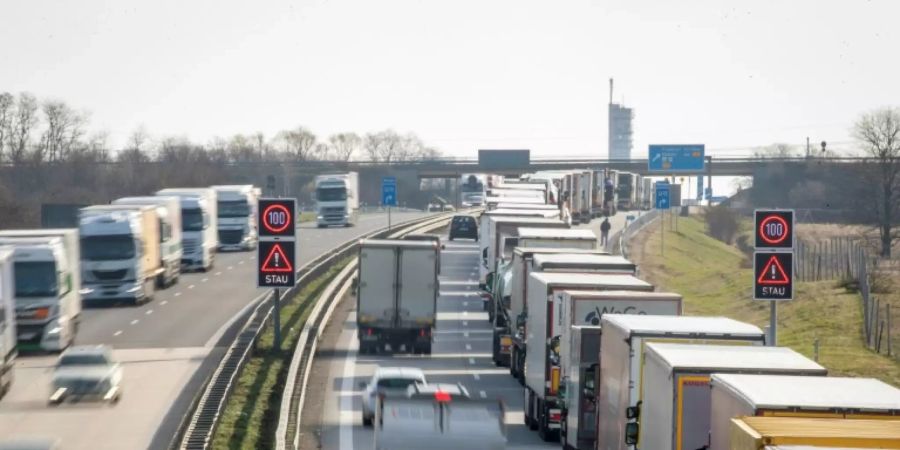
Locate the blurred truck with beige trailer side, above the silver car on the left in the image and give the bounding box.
[78,205,164,305]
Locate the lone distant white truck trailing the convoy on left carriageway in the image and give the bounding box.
[315,172,359,228]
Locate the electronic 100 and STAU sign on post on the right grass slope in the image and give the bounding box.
[753,210,794,346]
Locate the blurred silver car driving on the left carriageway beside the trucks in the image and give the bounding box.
[49,345,122,406]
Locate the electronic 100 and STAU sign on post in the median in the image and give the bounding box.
[256,198,297,351]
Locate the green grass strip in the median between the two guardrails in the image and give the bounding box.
[212,258,350,450]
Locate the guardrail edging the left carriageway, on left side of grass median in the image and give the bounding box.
[172,214,458,450]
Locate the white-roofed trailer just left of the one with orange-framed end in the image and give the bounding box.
[597,314,765,450]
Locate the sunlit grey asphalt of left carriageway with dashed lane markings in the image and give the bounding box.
[0,212,424,450]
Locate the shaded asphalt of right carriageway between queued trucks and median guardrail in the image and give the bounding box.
[300,213,636,450]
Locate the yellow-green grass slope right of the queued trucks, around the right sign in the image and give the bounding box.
[632,217,900,386]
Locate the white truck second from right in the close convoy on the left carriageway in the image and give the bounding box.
[155,188,219,272]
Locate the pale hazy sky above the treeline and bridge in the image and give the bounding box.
[0,0,900,156]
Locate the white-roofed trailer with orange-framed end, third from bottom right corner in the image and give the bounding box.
[626,342,828,450]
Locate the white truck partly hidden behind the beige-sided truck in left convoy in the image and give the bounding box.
[112,196,183,288]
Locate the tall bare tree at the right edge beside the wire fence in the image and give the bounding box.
[853,108,900,258]
